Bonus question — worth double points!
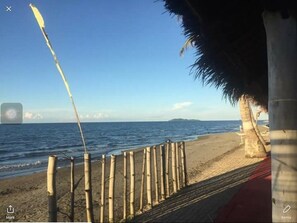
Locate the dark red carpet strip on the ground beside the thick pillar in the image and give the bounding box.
[215,157,272,222]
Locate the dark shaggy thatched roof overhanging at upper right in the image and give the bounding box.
[164,0,297,107]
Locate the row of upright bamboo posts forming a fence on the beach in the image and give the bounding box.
[47,142,188,222]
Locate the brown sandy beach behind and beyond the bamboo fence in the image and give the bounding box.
[0,130,268,221]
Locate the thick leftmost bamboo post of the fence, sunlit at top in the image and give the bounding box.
[47,156,57,222]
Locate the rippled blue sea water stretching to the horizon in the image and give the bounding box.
[0,121,264,179]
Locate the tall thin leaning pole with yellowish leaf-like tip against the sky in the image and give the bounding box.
[29,4,87,153]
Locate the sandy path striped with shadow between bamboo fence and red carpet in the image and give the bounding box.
[133,149,268,222]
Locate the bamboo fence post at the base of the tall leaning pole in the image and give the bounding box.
[84,153,94,222]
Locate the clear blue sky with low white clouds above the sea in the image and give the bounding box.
[0,0,265,122]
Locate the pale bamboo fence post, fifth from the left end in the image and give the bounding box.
[108,155,116,222]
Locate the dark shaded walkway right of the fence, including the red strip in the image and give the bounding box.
[133,159,271,222]
